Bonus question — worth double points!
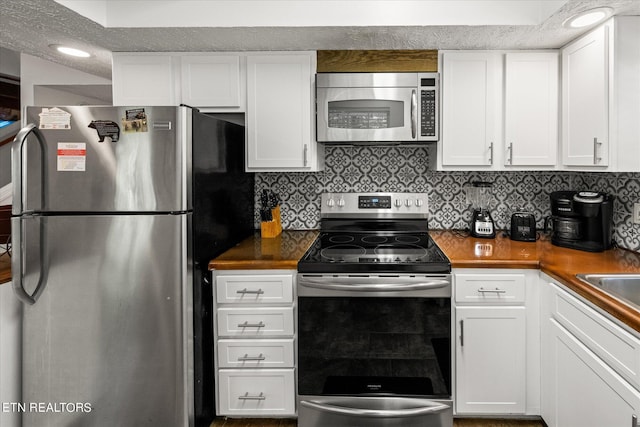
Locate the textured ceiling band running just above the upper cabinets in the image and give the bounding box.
[0,0,640,79]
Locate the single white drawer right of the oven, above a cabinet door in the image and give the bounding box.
[455,274,525,304]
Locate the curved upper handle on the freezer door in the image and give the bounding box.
[11,123,47,215]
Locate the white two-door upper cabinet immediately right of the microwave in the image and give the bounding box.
[438,51,559,170]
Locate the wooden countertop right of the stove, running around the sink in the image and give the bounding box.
[429,231,640,332]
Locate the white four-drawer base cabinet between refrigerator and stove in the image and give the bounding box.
[213,270,296,417]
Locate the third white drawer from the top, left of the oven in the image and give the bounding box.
[218,339,293,368]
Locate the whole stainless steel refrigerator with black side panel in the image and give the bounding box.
[12,107,254,427]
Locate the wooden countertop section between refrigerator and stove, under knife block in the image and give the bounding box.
[209,230,318,270]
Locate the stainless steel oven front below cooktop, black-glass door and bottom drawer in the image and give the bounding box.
[297,274,453,427]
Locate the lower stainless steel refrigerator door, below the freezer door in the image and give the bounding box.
[14,214,193,427]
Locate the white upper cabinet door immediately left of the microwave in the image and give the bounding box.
[247,53,316,171]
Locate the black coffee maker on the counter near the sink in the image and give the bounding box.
[544,191,614,252]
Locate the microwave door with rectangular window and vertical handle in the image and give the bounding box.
[316,87,418,142]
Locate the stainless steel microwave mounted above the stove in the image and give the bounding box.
[316,73,440,144]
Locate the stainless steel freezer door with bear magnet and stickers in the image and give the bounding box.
[12,106,191,213]
